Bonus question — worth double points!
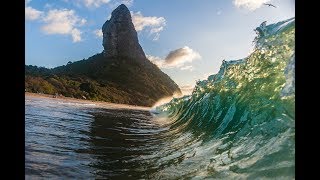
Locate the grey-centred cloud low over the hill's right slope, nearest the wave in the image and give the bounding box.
[147,46,201,70]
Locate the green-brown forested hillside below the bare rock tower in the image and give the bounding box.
[25,53,180,106]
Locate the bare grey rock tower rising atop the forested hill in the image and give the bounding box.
[102,4,146,59]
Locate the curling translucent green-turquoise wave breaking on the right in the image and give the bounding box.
[156,18,295,179]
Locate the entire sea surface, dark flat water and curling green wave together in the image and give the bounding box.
[25,18,295,179]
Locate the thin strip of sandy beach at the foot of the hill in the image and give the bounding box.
[24,92,151,111]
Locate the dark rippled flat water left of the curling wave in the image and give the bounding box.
[25,97,159,178]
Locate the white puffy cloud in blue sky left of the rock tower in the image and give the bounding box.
[41,9,86,42]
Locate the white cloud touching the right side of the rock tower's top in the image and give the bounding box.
[131,11,166,40]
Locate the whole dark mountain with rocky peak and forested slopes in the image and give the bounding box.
[25,5,181,106]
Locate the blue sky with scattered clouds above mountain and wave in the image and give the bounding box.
[25,0,295,93]
